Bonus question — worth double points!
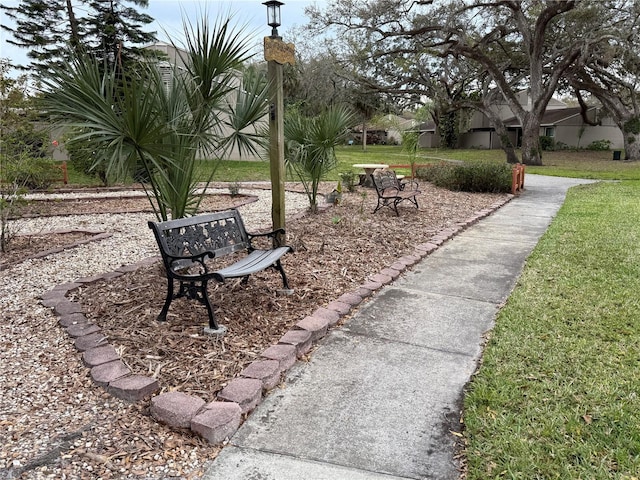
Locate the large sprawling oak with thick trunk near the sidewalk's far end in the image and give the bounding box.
[308,0,637,164]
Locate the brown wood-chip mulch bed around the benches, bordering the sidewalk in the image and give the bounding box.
[51,187,504,401]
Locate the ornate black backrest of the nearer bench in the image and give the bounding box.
[149,210,249,258]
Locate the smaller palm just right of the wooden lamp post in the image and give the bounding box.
[284,106,355,213]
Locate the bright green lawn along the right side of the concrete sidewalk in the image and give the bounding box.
[464,182,640,480]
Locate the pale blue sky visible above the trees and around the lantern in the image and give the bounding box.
[0,0,327,72]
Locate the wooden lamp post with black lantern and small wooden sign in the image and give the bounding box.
[263,0,294,243]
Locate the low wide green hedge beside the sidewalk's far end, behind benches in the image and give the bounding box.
[416,163,512,193]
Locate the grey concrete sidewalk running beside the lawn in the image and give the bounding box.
[203,175,585,480]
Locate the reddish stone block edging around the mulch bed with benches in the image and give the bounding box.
[41,196,513,443]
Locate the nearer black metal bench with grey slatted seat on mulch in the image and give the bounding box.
[149,210,293,333]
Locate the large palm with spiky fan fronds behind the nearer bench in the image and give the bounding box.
[43,16,268,220]
